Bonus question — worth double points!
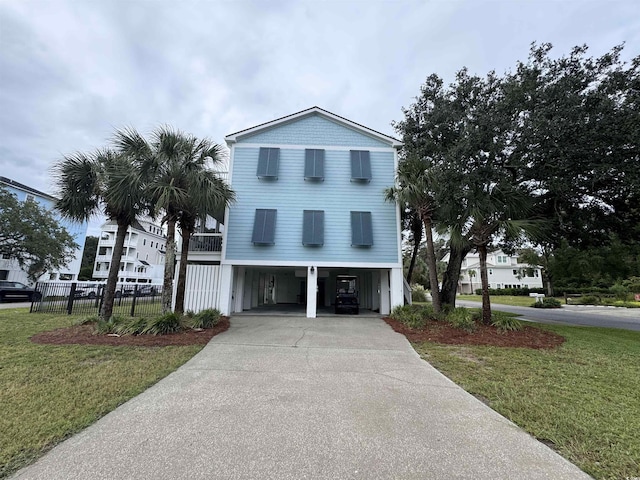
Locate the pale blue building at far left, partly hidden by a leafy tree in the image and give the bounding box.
[0,177,87,283]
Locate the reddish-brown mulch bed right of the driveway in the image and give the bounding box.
[384,317,564,349]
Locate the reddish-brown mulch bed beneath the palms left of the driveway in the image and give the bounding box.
[31,317,229,347]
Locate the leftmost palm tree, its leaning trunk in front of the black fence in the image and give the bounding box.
[53,149,149,320]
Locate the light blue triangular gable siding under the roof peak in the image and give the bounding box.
[238,114,390,148]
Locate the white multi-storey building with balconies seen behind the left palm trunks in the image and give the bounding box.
[93,220,167,283]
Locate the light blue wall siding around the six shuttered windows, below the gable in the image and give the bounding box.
[225,148,400,264]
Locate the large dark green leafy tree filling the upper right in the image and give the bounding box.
[394,44,640,304]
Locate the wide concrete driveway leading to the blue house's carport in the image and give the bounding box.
[14,316,590,480]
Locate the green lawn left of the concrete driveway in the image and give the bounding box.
[0,308,202,478]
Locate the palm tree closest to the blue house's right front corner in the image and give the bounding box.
[384,157,441,313]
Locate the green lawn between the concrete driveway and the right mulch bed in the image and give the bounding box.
[414,326,640,479]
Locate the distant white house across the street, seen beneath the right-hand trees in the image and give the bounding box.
[456,250,543,294]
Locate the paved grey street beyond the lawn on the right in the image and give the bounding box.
[456,300,640,331]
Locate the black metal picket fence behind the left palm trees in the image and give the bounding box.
[31,282,162,317]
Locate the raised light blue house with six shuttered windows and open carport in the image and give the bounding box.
[185,107,405,317]
